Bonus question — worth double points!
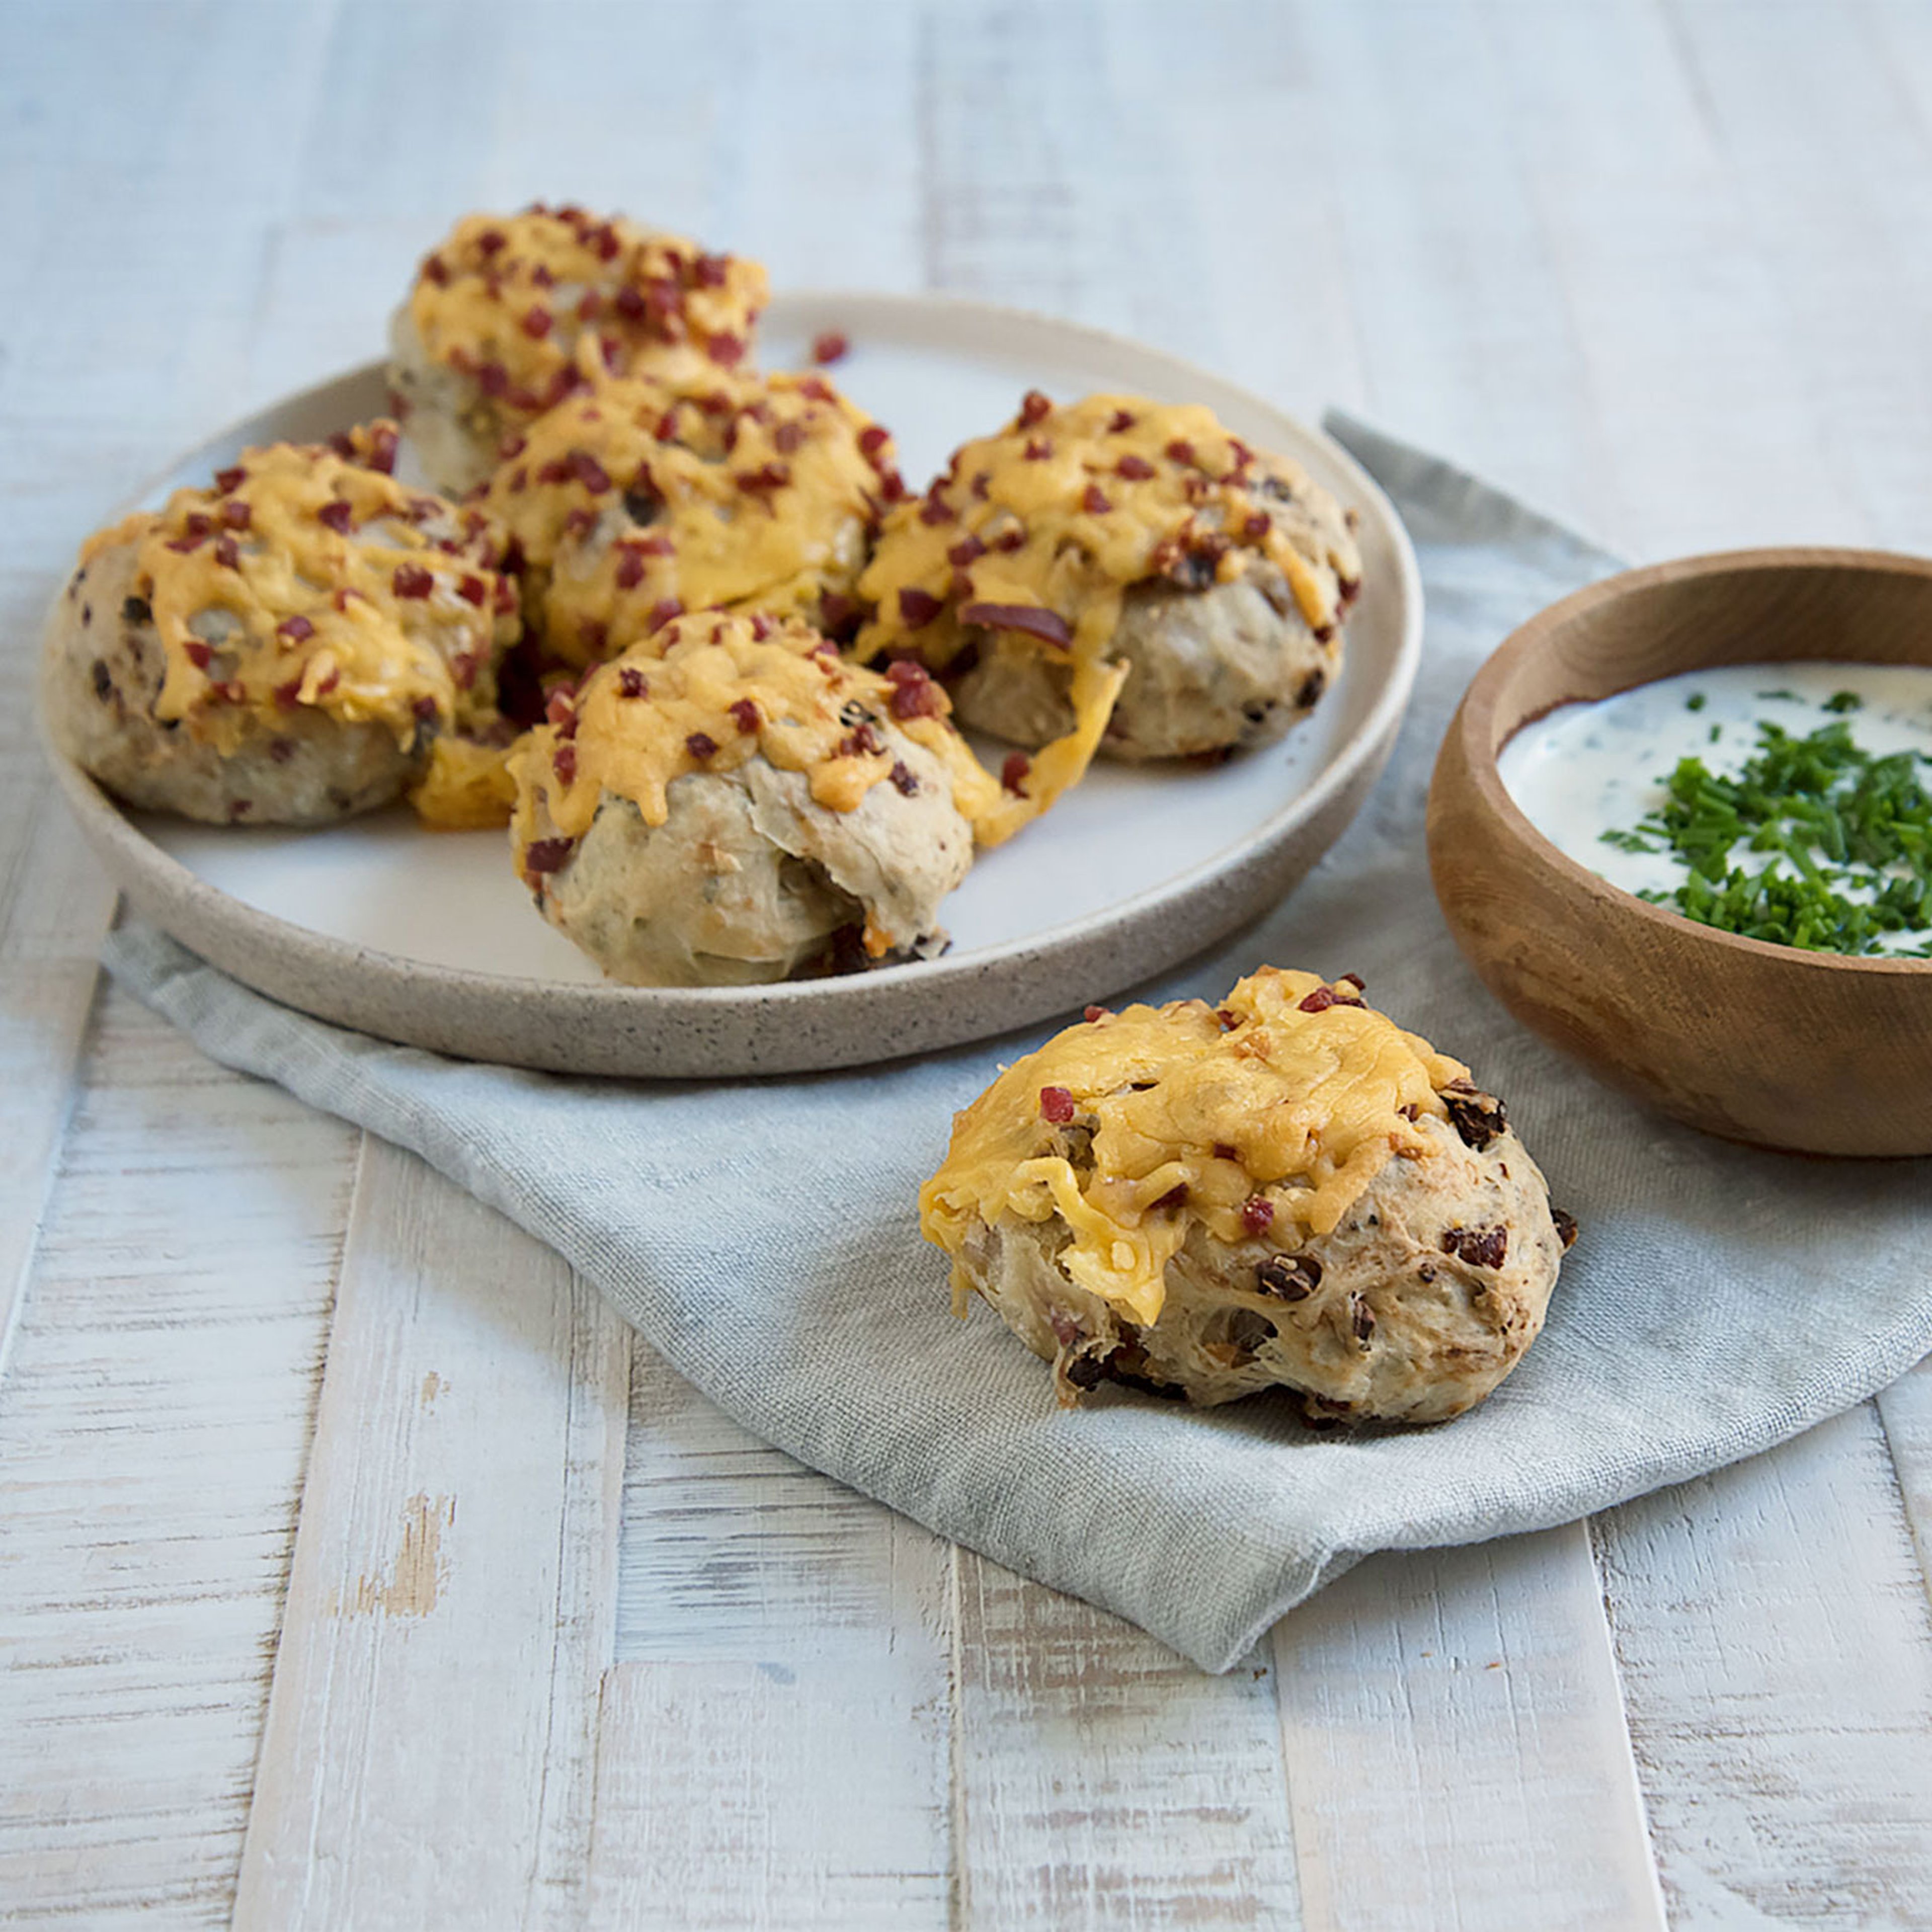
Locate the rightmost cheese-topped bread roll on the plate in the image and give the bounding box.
[860,390,1362,786]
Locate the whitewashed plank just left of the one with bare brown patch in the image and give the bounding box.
[0,991,354,1926]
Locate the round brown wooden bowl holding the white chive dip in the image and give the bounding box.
[1428,550,1932,1153]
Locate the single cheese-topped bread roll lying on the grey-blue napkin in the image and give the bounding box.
[920,966,1576,1422]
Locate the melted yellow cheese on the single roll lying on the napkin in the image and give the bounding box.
[920,966,1468,1327]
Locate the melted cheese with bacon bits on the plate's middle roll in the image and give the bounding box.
[483,369,900,665]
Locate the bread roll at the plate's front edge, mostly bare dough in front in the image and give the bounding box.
[510,612,999,985]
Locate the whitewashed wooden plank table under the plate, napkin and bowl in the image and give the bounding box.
[0,0,1932,1932]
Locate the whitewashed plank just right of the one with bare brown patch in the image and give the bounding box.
[591,1345,950,1932]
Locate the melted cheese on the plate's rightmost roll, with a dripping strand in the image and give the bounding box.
[858,390,1362,819]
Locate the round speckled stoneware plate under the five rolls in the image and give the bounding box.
[45,294,1422,1076]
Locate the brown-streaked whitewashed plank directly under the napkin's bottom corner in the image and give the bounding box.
[954,1552,1300,1928]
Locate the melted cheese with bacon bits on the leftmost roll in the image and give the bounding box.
[83,423,518,752]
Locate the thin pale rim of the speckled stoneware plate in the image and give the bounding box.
[35,288,1424,1078]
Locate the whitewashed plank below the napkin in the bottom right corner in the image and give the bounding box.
[1596,1405,1932,1928]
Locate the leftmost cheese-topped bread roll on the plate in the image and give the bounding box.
[42,423,518,825]
